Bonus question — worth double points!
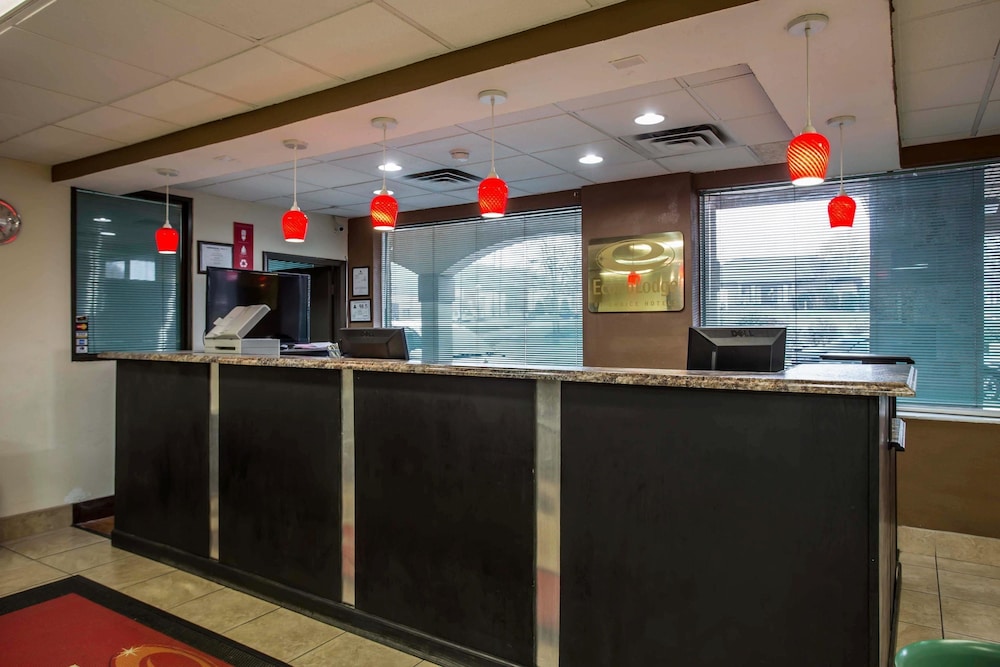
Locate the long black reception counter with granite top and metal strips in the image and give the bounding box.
[101,353,916,667]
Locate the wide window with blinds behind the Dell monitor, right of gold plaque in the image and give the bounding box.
[699,164,1000,412]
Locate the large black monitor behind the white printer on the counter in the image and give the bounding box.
[205,268,310,343]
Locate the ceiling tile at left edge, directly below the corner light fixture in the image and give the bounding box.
[0,28,164,102]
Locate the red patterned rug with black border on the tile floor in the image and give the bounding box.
[0,577,286,667]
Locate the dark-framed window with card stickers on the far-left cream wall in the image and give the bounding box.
[72,189,191,360]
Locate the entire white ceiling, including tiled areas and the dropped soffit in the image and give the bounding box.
[0,0,1000,217]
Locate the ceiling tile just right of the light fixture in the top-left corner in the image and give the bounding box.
[18,0,254,77]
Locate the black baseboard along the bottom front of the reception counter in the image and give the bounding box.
[111,528,516,667]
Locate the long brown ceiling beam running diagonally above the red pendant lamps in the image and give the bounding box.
[52,0,756,182]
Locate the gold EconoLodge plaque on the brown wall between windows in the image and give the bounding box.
[587,232,684,313]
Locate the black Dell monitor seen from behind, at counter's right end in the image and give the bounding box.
[688,327,785,373]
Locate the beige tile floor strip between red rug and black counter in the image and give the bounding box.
[0,528,437,667]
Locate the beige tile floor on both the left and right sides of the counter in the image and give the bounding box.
[0,526,1000,667]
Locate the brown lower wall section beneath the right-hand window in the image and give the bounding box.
[896,420,1000,538]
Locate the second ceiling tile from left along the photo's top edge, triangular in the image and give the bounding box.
[154,0,368,40]
